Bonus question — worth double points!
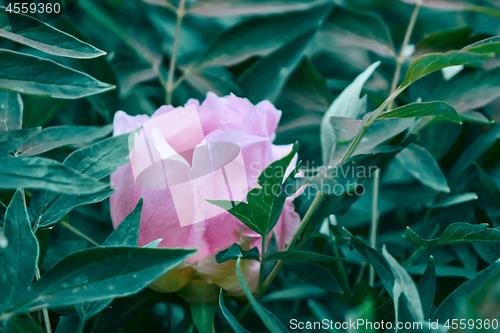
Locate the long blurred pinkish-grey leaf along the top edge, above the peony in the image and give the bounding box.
[188,0,328,17]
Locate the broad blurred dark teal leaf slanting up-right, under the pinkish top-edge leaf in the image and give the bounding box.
[200,6,329,67]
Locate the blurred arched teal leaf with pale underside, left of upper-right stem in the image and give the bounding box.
[317,7,396,57]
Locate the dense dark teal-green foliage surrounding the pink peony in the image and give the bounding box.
[0,0,500,332]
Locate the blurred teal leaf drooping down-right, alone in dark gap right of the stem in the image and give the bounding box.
[396,142,450,193]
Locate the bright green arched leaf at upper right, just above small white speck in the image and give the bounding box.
[401,51,494,87]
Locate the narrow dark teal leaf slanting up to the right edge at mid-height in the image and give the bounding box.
[448,124,500,183]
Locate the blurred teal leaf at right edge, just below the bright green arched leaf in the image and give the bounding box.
[432,67,500,113]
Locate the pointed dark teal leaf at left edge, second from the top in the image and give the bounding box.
[0,49,114,99]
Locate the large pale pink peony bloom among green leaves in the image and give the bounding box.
[111,93,300,295]
